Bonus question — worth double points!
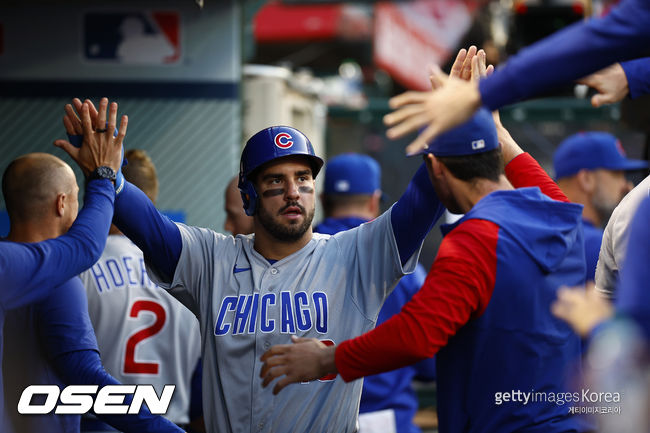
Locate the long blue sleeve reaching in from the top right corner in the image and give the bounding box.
[479,0,650,110]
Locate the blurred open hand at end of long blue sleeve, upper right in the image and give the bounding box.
[384,46,481,155]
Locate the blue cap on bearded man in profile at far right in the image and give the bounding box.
[553,131,648,179]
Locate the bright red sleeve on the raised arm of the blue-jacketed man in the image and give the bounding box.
[506,153,569,203]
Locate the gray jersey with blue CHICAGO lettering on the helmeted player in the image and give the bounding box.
[150,211,419,433]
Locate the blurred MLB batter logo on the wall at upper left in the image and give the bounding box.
[83,11,181,65]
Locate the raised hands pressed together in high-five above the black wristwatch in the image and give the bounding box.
[54,98,128,176]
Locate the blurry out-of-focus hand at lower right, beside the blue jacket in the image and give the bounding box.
[551,283,614,337]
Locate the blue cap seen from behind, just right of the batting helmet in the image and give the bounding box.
[325,153,381,194]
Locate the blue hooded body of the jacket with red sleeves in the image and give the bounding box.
[436,187,589,433]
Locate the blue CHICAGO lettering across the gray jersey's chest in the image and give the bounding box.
[214,291,328,336]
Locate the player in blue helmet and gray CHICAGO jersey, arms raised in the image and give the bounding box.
[58,96,443,432]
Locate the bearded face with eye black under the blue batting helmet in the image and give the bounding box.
[256,156,315,242]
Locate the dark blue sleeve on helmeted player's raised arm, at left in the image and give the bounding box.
[113,181,183,282]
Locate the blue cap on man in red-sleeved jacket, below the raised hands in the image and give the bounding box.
[417,108,499,156]
